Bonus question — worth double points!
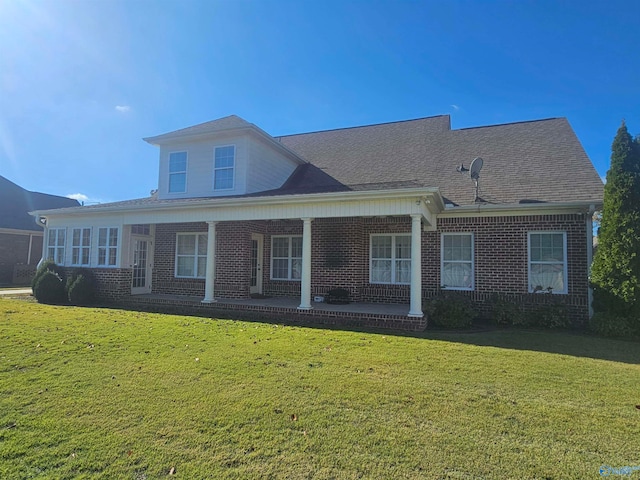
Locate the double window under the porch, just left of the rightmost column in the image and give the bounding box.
[369,235,411,285]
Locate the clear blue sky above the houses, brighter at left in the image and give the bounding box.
[0,0,640,203]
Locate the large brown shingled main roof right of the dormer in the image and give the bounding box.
[278,115,603,205]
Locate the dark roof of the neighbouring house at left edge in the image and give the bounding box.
[0,176,80,231]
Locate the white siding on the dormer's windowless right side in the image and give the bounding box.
[246,139,297,193]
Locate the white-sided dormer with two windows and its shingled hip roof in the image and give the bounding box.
[144,115,306,199]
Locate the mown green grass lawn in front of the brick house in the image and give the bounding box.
[0,299,640,479]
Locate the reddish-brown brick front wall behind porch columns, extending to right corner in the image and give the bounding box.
[141,214,588,323]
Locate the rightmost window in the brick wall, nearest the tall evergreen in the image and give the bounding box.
[529,232,567,293]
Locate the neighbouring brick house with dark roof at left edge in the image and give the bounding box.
[0,176,80,285]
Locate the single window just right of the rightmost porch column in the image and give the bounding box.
[440,233,473,290]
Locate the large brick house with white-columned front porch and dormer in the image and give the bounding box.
[33,115,603,328]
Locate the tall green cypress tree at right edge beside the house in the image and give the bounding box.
[591,121,640,318]
